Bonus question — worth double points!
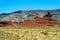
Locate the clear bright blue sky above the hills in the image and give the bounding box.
[0,0,60,13]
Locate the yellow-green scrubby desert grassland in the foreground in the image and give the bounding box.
[0,28,60,40]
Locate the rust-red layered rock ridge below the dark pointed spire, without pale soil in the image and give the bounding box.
[0,16,57,28]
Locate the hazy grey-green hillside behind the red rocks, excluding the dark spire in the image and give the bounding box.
[0,10,60,22]
